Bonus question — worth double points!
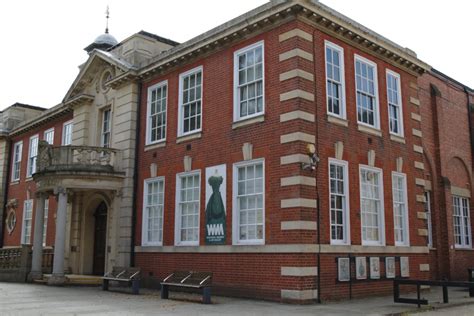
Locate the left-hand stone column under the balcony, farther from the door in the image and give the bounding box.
[28,193,46,281]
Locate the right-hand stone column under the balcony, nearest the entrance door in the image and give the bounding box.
[48,188,67,285]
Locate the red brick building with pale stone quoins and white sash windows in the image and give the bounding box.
[3,0,474,302]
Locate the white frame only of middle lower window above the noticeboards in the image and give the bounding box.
[359,165,385,246]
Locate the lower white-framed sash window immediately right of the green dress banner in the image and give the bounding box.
[232,159,265,244]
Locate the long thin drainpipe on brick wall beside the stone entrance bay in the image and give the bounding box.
[130,82,142,267]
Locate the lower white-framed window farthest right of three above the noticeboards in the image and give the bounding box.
[392,172,410,246]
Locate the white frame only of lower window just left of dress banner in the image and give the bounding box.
[174,170,202,246]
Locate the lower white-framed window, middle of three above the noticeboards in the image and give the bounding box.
[360,166,384,245]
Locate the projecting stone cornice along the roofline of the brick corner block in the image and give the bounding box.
[139,0,431,80]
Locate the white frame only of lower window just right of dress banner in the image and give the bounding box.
[232,158,266,245]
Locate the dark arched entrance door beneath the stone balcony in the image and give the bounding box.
[92,202,107,275]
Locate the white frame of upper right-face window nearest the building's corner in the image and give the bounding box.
[324,40,347,120]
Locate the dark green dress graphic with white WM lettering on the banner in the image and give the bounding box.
[206,176,226,244]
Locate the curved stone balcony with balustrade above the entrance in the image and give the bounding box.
[33,141,125,190]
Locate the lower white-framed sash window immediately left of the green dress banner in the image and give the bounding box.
[175,171,201,246]
